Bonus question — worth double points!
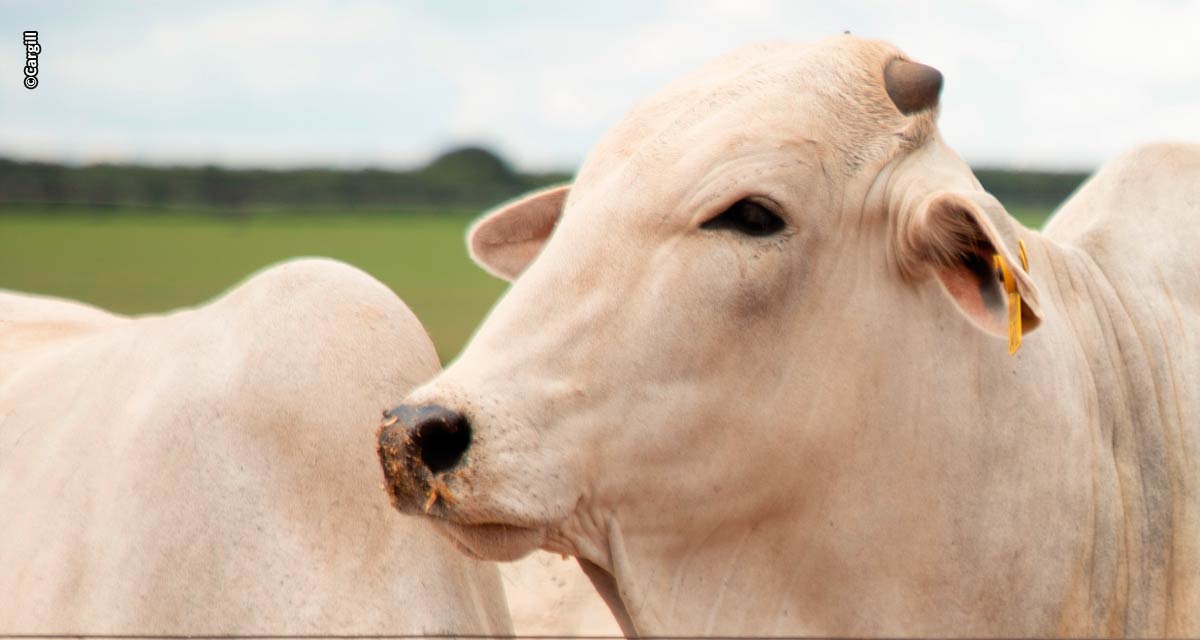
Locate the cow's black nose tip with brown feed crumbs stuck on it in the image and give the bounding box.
[378,405,470,513]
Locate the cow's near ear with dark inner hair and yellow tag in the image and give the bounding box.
[896,190,1042,352]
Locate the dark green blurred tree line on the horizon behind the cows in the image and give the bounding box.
[0,146,1087,214]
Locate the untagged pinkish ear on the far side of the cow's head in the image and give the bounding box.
[467,185,570,281]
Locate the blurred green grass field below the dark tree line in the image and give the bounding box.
[0,209,1048,363]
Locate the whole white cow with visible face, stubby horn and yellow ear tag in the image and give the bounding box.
[379,36,1200,636]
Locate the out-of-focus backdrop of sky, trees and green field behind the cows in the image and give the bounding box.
[0,0,1200,361]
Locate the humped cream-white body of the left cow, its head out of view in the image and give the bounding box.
[0,261,510,634]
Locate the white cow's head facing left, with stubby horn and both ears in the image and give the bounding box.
[379,36,1075,633]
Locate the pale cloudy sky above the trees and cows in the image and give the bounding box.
[0,0,1200,171]
